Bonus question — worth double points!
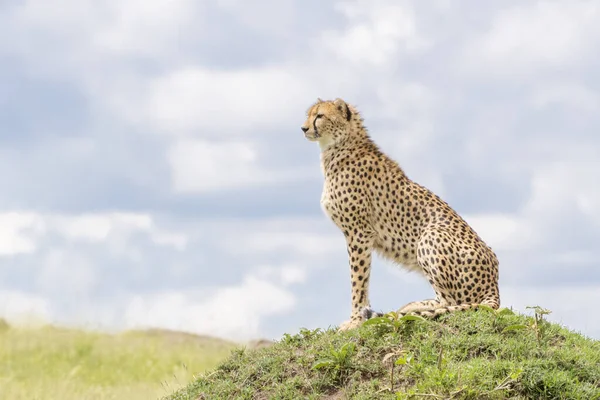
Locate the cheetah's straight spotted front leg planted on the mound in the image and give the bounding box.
[339,232,375,331]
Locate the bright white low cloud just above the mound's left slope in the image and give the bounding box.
[125,276,296,340]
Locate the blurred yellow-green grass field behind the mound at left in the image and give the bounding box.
[0,320,235,400]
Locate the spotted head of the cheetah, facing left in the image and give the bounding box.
[301,98,355,148]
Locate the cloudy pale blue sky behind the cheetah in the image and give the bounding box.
[0,0,600,341]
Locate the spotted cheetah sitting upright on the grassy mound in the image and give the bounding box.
[301,98,500,330]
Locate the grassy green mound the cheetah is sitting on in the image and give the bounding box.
[166,308,600,400]
